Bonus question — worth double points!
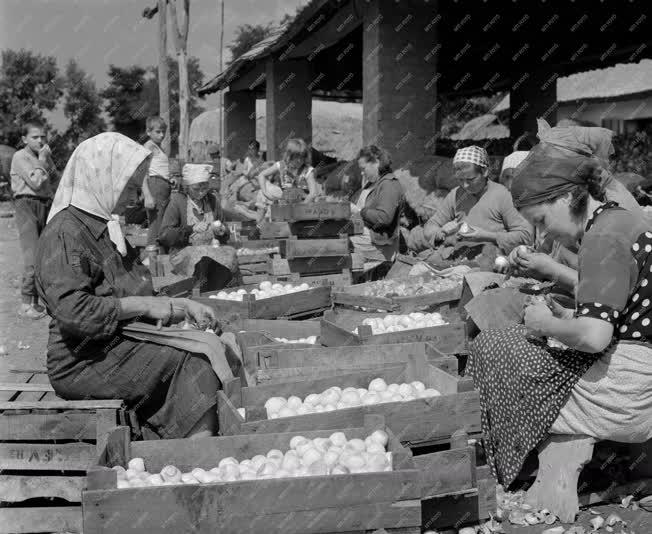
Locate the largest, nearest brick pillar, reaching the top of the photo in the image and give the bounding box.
[362,0,442,166]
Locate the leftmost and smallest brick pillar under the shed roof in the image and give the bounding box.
[224,91,256,160]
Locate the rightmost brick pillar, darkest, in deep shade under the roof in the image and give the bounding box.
[509,68,557,139]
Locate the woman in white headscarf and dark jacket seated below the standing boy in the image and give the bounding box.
[158,163,229,254]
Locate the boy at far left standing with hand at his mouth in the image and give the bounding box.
[10,121,59,319]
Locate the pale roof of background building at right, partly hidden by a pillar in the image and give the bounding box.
[492,59,652,113]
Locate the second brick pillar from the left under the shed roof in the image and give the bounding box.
[266,58,312,160]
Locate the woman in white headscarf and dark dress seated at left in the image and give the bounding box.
[36,133,220,438]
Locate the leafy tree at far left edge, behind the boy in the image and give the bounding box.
[0,50,63,147]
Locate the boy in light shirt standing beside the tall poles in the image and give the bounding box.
[143,116,174,245]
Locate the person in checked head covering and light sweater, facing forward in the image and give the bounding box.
[407,146,533,253]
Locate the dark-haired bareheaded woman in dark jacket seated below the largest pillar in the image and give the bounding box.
[351,145,403,264]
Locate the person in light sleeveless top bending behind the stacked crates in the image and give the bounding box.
[258,139,320,216]
